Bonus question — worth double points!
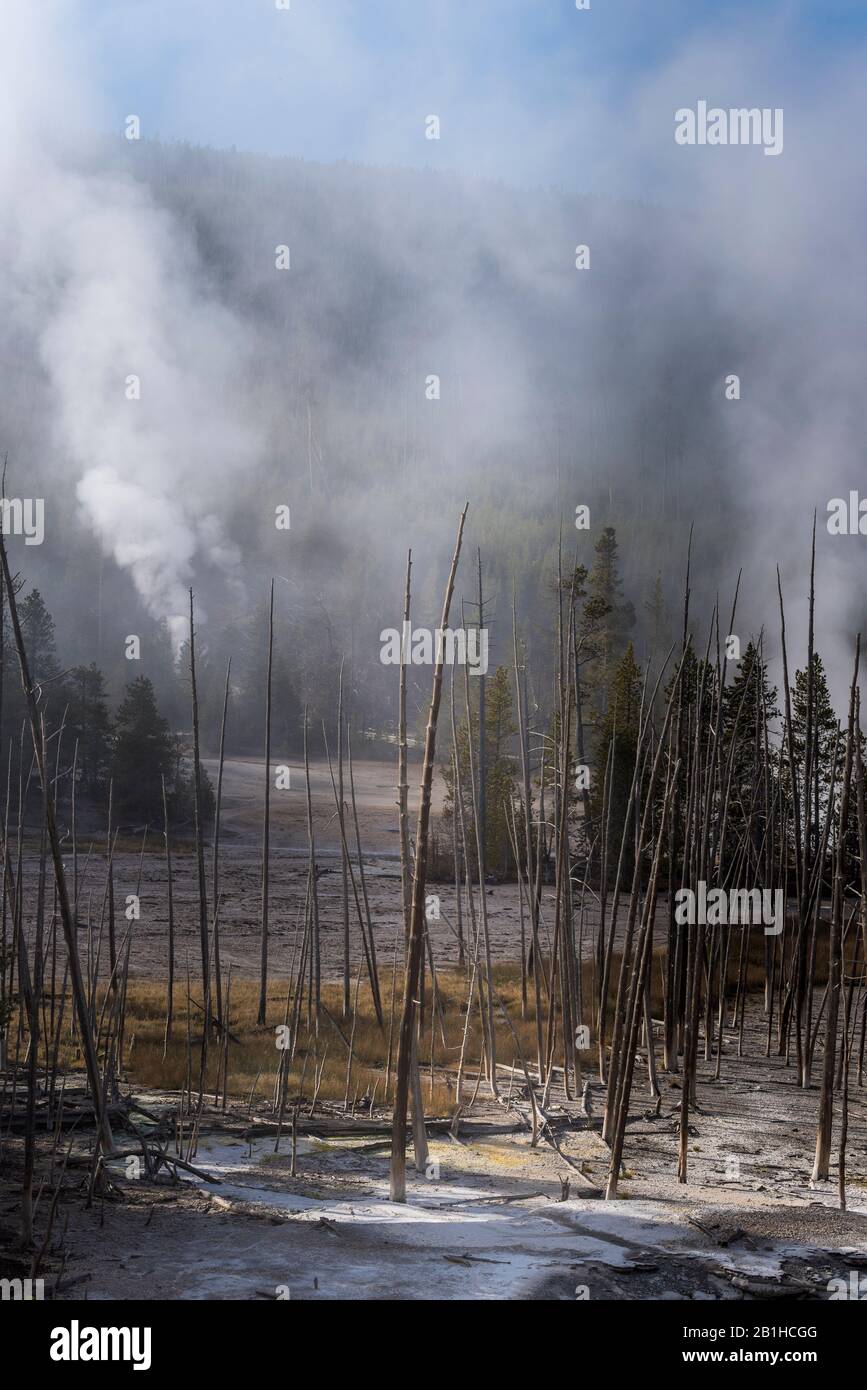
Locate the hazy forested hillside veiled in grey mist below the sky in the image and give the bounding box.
[0,140,828,746]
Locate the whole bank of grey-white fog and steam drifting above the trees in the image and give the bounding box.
[0,3,867,717]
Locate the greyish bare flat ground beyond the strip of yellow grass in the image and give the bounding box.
[25,759,644,979]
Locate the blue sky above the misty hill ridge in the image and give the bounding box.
[64,0,867,197]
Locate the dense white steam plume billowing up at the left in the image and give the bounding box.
[0,3,260,631]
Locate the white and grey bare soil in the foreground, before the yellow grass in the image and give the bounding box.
[16,1001,867,1300]
